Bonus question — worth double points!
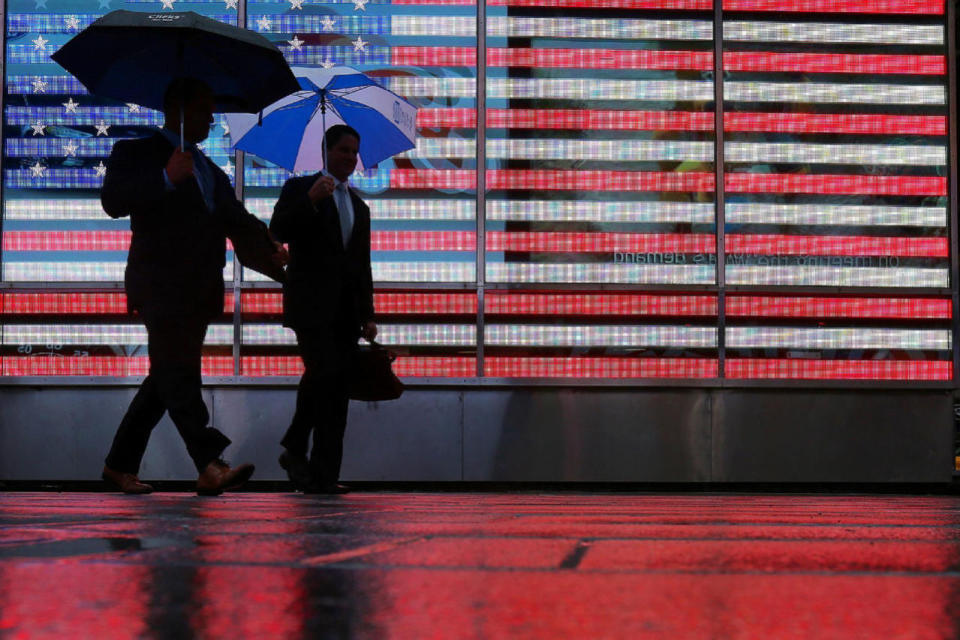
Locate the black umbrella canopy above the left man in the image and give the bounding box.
[51,9,300,113]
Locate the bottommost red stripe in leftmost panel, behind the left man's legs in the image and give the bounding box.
[3,356,233,377]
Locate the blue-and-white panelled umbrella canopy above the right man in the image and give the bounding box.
[227,67,417,171]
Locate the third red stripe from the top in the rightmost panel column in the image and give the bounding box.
[723,113,947,136]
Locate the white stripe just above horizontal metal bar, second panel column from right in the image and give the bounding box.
[487,262,714,284]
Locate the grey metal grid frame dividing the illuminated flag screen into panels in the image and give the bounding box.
[0,0,960,391]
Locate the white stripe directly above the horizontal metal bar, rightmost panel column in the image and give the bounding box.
[727,265,950,288]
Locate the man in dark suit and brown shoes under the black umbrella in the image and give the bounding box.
[100,78,286,495]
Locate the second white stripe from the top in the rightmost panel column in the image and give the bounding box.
[723,81,947,105]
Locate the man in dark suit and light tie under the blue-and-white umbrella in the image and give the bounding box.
[270,125,377,493]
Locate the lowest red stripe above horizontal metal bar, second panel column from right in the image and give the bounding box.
[487,231,716,253]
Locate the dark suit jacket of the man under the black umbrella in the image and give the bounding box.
[100,133,273,319]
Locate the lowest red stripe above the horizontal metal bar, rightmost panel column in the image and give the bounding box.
[726,234,950,258]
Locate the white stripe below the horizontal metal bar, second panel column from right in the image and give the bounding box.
[492,324,717,348]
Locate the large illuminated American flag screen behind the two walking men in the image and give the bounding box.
[0,0,954,384]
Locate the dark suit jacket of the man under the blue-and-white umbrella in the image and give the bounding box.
[270,174,373,336]
